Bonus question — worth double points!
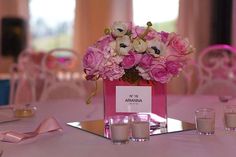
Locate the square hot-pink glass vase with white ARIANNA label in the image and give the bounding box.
[103,80,167,128]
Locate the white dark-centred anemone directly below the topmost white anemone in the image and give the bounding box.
[116,35,132,55]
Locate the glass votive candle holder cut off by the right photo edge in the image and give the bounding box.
[224,105,236,130]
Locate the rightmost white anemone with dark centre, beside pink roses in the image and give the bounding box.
[147,38,166,57]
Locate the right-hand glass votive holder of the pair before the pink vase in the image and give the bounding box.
[130,113,150,141]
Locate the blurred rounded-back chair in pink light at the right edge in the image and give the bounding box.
[196,44,236,96]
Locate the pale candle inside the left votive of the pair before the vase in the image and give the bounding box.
[110,124,129,143]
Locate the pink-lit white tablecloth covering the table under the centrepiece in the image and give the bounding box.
[0,96,236,157]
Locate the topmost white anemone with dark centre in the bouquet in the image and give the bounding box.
[111,21,128,37]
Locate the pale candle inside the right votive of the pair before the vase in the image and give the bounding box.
[132,121,150,141]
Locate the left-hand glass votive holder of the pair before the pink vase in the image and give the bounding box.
[108,115,130,144]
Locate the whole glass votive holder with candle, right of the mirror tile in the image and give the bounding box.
[195,108,215,135]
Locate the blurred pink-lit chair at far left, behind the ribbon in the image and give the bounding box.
[10,49,48,104]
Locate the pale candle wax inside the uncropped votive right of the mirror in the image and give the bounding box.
[197,118,215,134]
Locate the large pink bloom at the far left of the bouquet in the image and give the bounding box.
[83,47,103,75]
